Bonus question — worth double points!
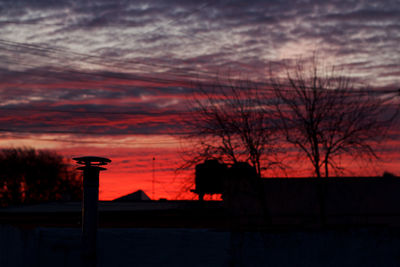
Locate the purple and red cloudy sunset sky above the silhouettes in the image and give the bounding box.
[0,0,400,200]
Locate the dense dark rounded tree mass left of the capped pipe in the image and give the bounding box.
[0,148,82,205]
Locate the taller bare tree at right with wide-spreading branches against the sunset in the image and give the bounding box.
[271,56,398,177]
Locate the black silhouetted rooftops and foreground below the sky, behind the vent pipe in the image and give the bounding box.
[0,160,400,266]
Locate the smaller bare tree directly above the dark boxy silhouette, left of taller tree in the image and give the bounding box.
[181,80,277,175]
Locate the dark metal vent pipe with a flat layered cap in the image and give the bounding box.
[74,157,111,267]
